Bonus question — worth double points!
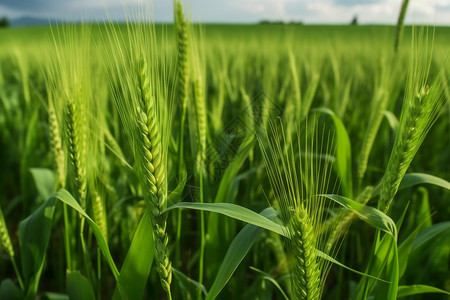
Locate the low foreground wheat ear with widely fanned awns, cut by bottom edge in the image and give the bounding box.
[260,119,336,299]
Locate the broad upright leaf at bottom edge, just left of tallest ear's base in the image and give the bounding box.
[113,212,155,300]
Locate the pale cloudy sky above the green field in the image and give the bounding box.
[0,0,450,25]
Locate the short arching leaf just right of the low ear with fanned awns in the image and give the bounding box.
[319,194,397,240]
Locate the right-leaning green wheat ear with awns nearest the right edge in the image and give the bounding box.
[378,28,448,212]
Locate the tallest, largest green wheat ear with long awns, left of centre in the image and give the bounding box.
[104,16,172,299]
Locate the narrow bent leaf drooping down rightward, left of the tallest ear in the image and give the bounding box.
[51,189,119,280]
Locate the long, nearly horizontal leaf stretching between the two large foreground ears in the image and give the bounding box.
[163,202,288,236]
